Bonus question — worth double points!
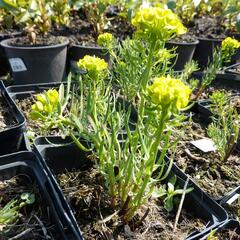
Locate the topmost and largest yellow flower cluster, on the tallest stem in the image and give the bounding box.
[132,7,187,41]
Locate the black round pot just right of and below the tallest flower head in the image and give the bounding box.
[166,40,199,71]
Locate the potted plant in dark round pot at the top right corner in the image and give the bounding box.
[193,1,239,68]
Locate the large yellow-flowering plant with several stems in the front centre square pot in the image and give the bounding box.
[19,8,228,239]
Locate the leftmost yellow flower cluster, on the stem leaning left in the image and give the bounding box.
[32,89,59,115]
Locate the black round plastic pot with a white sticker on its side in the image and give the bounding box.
[1,39,69,85]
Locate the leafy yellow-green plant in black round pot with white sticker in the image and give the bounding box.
[1,0,68,84]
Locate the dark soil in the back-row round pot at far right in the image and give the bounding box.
[189,16,227,39]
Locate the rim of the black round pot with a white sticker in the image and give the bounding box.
[0,37,69,50]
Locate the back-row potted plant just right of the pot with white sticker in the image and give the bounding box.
[68,0,133,66]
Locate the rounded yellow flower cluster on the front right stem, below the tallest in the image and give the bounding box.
[148,76,191,110]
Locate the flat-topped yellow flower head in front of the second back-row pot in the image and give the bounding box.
[77,55,108,73]
